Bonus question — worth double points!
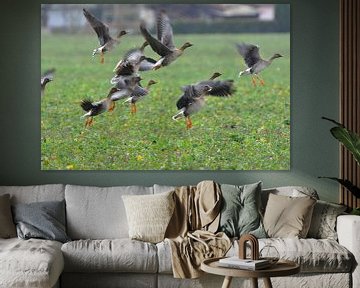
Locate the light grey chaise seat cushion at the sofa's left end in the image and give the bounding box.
[0,238,64,288]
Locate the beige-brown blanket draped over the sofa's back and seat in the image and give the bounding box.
[165,181,231,278]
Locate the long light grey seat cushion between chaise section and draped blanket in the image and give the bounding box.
[61,239,158,273]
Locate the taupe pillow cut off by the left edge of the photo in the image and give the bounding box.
[0,194,16,238]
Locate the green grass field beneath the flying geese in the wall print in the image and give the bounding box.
[39,34,290,170]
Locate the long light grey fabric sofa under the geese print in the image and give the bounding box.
[0,184,360,288]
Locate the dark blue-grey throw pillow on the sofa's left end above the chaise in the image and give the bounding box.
[13,201,70,243]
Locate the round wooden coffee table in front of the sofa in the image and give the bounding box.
[201,257,300,288]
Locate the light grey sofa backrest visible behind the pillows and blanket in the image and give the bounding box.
[0,184,319,240]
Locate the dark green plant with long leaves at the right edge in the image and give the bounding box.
[319,117,360,215]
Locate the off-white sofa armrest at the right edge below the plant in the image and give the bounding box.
[336,215,360,287]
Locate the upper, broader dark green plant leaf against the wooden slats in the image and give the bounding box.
[322,117,360,165]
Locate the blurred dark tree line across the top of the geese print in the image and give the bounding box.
[41,4,290,33]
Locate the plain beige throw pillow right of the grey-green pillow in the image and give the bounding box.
[264,194,316,238]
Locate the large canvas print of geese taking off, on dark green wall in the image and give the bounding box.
[40,3,291,170]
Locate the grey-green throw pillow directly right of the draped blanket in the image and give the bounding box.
[219,182,266,238]
